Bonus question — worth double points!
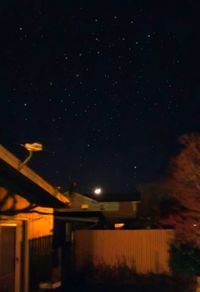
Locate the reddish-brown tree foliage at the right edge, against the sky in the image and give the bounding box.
[165,134,200,246]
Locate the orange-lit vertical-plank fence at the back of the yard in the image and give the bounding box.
[74,230,174,274]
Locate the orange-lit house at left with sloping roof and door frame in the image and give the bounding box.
[0,145,70,292]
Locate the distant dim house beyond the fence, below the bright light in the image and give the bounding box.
[55,192,140,229]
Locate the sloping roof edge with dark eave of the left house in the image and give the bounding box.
[0,145,70,208]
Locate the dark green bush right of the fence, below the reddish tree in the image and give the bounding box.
[169,240,200,277]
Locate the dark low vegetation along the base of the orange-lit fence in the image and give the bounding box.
[70,263,195,292]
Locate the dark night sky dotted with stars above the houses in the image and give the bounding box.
[0,0,200,193]
